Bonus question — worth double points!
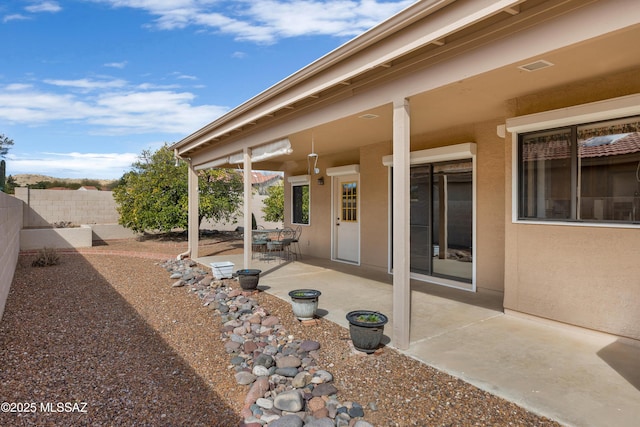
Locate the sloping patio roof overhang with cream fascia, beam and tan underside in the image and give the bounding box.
[172,0,639,170]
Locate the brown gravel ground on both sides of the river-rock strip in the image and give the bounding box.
[0,235,558,426]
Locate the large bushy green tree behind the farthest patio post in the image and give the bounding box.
[113,144,243,232]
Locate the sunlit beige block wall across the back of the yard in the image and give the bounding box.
[15,187,119,228]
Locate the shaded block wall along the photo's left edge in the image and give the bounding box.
[0,192,23,319]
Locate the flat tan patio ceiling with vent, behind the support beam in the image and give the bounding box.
[272,22,640,166]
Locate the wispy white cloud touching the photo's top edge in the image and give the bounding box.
[94,0,414,43]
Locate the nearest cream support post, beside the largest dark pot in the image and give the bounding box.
[392,99,411,349]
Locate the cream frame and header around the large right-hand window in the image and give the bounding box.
[504,94,640,229]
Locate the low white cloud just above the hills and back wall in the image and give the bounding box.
[7,152,138,179]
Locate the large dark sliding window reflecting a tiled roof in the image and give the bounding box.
[518,116,640,223]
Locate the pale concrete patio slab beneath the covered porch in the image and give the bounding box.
[198,255,640,427]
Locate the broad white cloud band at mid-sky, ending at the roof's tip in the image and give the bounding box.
[0,79,228,135]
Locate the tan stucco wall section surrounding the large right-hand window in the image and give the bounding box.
[504,70,640,339]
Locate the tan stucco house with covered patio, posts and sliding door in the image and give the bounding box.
[172,0,640,348]
